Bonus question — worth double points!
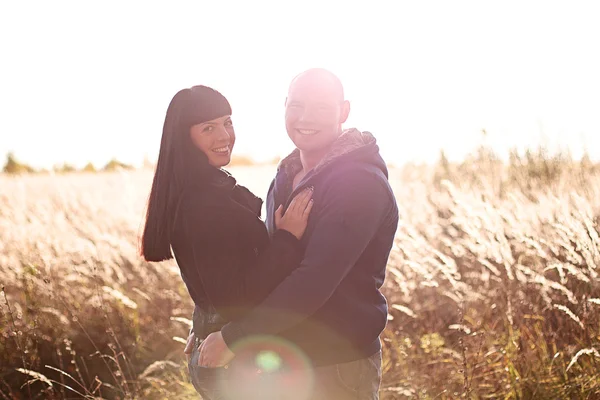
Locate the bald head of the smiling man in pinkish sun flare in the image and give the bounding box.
[285,76,350,152]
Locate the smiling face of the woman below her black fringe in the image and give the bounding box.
[190,115,235,168]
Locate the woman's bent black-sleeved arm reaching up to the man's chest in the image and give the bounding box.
[184,200,301,320]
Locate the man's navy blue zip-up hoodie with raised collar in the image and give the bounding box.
[222,129,398,366]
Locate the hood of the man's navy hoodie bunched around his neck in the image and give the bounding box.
[277,128,388,177]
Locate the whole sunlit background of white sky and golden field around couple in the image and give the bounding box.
[0,0,600,400]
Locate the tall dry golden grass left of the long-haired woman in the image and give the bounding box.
[0,172,197,398]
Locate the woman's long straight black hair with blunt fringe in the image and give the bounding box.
[141,86,231,262]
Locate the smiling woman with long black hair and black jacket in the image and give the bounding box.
[142,86,312,399]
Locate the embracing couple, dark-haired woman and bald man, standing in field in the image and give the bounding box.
[142,69,398,400]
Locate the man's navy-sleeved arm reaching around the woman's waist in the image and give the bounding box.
[221,171,391,348]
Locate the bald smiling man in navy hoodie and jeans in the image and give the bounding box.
[188,69,398,400]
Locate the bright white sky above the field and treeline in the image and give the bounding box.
[0,0,600,167]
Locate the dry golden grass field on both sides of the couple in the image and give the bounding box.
[0,163,600,399]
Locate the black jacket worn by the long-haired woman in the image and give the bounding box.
[171,169,301,337]
